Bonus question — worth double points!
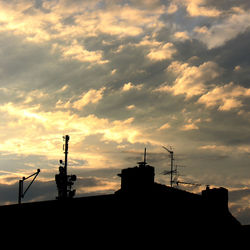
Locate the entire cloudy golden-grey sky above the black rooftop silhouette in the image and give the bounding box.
[0,0,250,224]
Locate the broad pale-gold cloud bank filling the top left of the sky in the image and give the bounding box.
[0,0,166,69]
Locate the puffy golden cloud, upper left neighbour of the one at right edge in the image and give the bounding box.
[156,61,219,98]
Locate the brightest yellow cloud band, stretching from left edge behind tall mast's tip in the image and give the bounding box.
[0,98,145,157]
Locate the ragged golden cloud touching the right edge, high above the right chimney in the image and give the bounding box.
[198,82,250,111]
